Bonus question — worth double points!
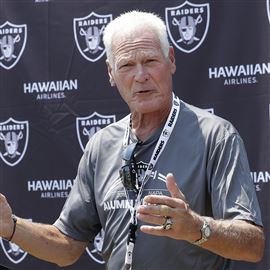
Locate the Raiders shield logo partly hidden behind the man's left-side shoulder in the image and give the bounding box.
[76,112,116,151]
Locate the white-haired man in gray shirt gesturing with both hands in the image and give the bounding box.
[0,11,264,270]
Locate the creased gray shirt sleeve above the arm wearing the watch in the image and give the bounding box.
[207,133,262,226]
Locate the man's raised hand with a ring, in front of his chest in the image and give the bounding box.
[137,173,203,242]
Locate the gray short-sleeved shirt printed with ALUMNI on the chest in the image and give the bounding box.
[54,101,262,270]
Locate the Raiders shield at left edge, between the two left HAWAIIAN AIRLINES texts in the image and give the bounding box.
[0,118,29,166]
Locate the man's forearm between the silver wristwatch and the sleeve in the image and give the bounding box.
[202,218,265,262]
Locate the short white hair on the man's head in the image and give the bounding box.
[103,10,170,63]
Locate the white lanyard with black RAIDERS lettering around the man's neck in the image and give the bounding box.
[123,94,180,270]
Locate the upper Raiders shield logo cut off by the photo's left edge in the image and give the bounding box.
[0,21,27,69]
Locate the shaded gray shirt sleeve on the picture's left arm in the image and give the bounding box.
[54,144,101,241]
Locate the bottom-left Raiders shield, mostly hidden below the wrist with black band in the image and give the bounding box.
[0,238,27,264]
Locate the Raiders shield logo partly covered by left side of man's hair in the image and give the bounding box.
[73,12,112,62]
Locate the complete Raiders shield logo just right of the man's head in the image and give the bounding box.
[165,1,210,53]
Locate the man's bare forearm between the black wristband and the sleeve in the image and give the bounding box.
[9,218,87,266]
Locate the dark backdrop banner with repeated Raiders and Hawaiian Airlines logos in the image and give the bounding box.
[0,0,270,270]
